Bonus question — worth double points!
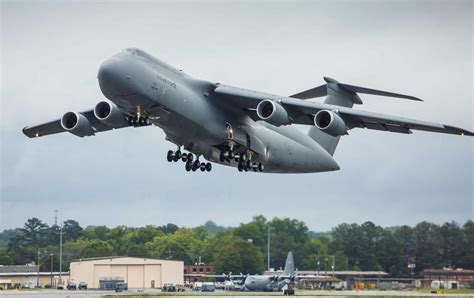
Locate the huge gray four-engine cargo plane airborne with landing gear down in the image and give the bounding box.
[23,48,474,173]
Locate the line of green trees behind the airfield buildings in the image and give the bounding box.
[0,215,474,277]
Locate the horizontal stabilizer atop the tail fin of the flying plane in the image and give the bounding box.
[290,77,422,101]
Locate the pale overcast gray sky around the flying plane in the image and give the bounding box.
[0,1,474,231]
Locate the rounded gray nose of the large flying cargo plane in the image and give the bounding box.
[97,57,137,96]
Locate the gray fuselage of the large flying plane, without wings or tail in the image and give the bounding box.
[98,49,339,173]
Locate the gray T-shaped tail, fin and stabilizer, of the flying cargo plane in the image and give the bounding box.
[290,77,422,155]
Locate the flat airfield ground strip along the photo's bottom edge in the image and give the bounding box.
[0,289,474,298]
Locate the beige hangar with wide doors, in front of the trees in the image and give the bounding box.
[70,257,184,289]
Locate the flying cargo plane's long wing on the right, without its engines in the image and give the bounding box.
[214,85,474,136]
